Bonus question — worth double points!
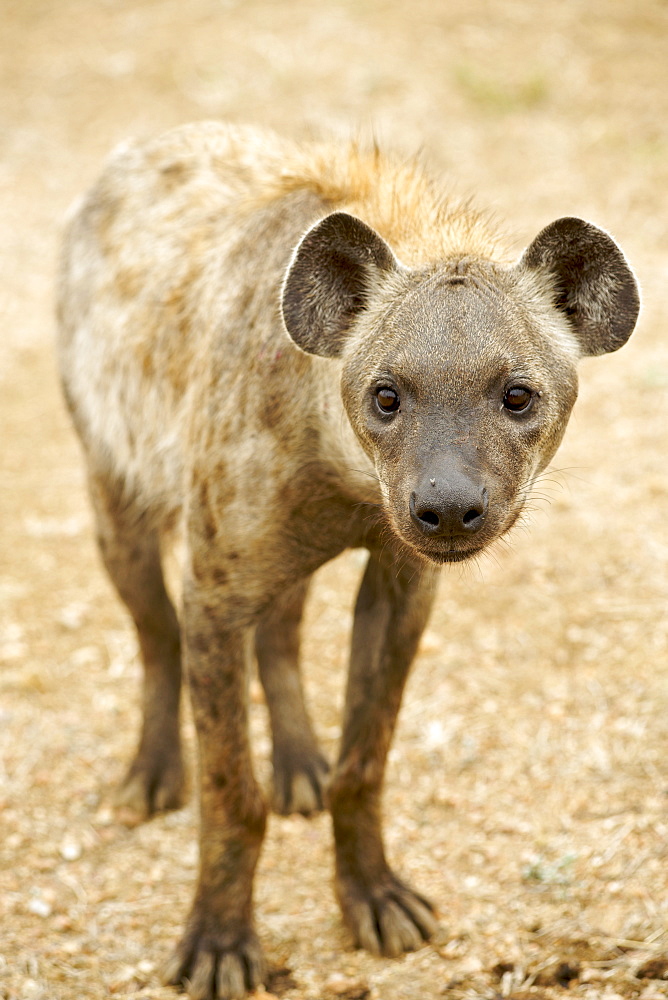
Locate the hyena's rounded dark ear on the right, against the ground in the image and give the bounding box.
[519,218,640,355]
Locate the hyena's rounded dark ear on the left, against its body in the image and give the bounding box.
[282,212,399,358]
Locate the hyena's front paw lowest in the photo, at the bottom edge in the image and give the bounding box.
[163,928,266,1000]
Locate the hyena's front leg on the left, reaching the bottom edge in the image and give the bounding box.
[164,586,267,1000]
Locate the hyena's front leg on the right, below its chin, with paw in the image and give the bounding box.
[329,553,437,956]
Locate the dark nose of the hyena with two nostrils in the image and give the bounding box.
[409,479,489,537]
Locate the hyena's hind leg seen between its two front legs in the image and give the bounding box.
[255,579,329,816]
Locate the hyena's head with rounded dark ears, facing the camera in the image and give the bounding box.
[282,212,639,562]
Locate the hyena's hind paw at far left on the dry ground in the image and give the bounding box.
[114,746,185,826]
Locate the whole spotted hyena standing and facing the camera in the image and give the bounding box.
[59,123,638,998]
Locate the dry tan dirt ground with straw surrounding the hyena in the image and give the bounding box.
[0,0,668,1000]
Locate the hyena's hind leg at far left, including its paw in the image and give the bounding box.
[90,477,185,824]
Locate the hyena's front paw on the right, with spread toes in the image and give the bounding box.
[337,871,438,958]
